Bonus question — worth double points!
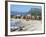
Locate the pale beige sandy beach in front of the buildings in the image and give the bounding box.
[10,19,42,31]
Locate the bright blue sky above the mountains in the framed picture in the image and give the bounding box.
[10,4,40,12]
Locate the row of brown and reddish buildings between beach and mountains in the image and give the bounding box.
[13,14,41,21]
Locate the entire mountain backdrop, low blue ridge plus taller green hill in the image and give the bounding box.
[11,8,41,16]
